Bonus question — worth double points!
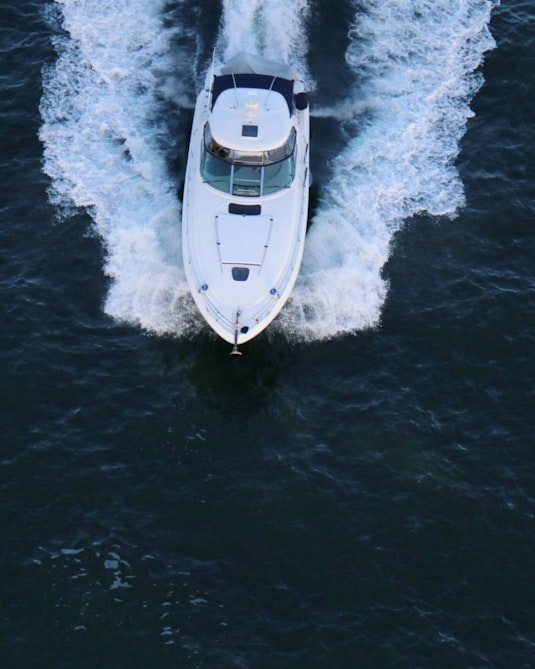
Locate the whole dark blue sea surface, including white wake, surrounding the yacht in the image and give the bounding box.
[0,0,535,669]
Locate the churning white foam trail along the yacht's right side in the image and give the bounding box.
[283,0,494,340]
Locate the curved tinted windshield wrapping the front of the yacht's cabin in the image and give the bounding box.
[201,123,295,197]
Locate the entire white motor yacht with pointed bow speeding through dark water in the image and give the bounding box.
[182,53,309,353]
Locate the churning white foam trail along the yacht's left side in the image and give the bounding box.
[40,0,195,334]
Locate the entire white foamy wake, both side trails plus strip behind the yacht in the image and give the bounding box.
[41,0,494,340]
